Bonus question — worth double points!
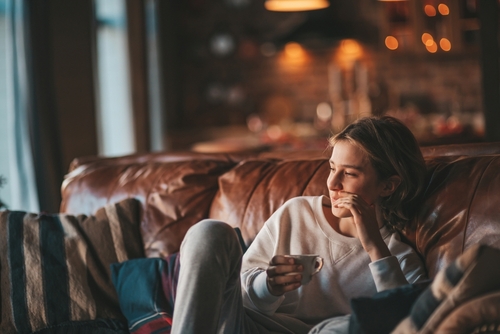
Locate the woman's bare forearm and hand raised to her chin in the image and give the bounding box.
[332,191,391,261]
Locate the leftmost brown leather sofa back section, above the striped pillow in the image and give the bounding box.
[61,155,236,257]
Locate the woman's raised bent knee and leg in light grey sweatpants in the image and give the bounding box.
[172,220,255,334]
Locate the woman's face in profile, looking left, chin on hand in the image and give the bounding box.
[326,141,385,218]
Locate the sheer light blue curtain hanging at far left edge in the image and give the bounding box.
[0,0,39,212]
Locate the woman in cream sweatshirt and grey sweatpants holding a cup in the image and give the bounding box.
[172,117,425,333]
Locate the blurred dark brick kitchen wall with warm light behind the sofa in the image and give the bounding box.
[163,0,492,148]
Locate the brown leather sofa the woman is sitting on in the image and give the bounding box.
[61,143,500,332]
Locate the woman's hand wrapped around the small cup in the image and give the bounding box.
[266,255,304,296]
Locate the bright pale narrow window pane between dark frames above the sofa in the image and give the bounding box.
[95,0,136,156]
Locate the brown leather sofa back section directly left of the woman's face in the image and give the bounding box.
[209,156,330,246]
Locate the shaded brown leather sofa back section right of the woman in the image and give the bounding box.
[414,155,500,278]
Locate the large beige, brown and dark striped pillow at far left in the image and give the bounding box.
[0,199,144,333]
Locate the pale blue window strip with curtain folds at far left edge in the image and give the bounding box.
[0,0,39,212]
